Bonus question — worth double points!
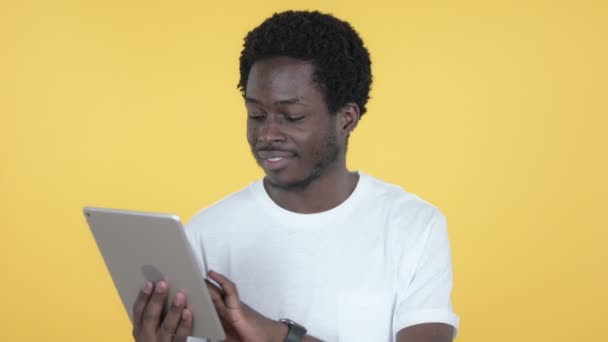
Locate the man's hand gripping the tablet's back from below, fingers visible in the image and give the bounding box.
[133,281,192,342]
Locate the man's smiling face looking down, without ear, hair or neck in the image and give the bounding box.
[245,57,341,189]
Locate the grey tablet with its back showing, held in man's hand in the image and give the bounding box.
[84,207,226,340]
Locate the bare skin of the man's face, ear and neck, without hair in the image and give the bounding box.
[245,58,360,213]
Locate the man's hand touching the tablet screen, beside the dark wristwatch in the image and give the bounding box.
[207,271,288,342]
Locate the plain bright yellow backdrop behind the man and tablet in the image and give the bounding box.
[0,0,608,342]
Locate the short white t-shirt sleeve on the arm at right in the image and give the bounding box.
[393,210,459,335]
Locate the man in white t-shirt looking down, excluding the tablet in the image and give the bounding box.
[133,11,458,342]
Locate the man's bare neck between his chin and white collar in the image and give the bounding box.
[264,166,359,214]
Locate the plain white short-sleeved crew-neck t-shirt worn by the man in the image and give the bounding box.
[186,172,458,342]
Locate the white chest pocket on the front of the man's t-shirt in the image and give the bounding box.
[338,291,394,342]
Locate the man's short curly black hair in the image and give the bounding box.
[238,11,372,115]
